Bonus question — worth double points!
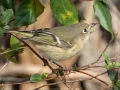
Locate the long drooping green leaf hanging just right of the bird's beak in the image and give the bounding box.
[93,0,114,39]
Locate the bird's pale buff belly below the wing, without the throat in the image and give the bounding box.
[36,45,80,62]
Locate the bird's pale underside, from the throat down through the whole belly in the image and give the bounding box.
[36,34,88,61]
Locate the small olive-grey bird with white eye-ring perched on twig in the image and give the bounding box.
[8,23,96,62]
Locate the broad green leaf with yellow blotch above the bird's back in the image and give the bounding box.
[50,0,78,25]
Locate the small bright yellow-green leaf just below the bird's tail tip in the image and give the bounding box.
[10,36,20,48]
